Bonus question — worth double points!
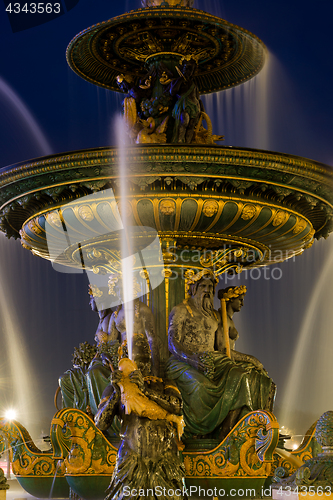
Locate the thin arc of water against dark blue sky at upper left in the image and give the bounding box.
[0,77,53,165]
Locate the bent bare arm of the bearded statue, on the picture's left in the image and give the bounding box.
[168,305,206,371]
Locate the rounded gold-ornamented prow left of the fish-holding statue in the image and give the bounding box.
[51,408,117,475]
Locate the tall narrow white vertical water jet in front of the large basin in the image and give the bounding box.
[116,116,134,359]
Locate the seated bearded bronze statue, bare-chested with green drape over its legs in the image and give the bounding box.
[166,270,275,439]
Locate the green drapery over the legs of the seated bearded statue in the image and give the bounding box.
[166,352,273,436]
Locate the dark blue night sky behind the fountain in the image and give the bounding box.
[0,0,333,446]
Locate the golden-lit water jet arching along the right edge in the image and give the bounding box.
[280,239,333,431]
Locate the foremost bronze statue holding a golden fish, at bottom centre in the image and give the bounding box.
[95,334,186,500]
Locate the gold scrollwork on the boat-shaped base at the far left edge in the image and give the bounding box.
[0,420,65,477]
